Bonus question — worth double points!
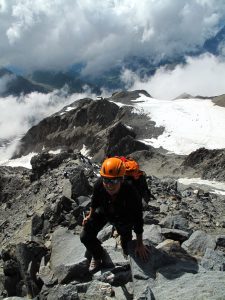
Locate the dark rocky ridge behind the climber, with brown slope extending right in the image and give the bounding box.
[10,90,225,181]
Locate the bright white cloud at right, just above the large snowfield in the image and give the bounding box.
[122,54,225,99]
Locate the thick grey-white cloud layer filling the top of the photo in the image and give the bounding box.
[0,0,225,74]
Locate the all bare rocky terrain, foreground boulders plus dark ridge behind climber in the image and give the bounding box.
[0,91,225,300]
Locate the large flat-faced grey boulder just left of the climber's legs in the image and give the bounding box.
[50,227,88,283]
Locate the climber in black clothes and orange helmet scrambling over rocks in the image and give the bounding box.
[80,157,149,272]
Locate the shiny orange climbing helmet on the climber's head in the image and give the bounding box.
[100,157,126,178]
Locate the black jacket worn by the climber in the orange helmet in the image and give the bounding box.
[91,178,143,234]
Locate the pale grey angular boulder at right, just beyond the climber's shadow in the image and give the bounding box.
[182,230,216,256]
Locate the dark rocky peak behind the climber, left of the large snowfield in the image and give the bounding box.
[15,92,163,159]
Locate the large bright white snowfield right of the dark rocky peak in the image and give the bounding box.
[133,96,225,155]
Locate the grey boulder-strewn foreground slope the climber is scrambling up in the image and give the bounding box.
[0,151,225,300]
